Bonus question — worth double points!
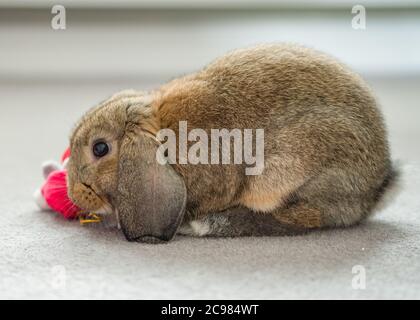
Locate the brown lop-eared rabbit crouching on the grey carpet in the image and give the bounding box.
[68,44,396,243]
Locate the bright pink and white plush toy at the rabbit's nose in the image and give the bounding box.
[34,148,100,224]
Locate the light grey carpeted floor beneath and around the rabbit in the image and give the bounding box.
[0,77,420,299]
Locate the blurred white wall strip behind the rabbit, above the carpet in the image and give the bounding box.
[0,5,420,81]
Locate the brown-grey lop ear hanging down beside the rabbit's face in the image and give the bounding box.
[116,133,187,243]
